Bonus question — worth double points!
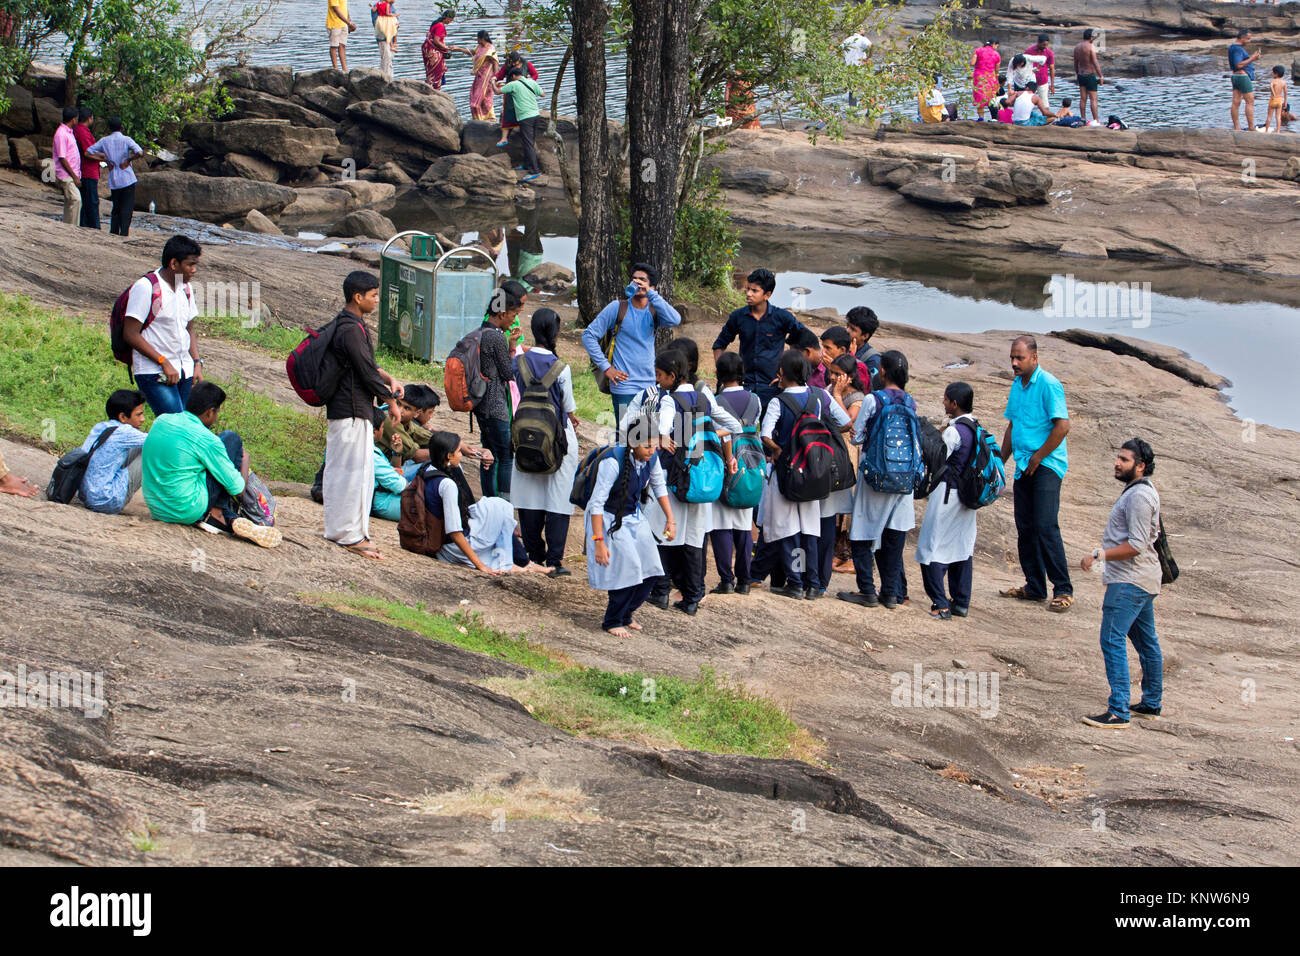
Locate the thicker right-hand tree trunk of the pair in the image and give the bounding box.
[628,0,694,340]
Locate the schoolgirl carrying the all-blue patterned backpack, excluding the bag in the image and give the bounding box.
[836,349,917,610]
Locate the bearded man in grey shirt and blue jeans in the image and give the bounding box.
[1080,438,1164,727]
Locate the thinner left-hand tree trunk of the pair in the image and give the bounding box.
[569,0,623,326]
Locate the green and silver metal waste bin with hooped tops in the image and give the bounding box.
[380,232,497,362]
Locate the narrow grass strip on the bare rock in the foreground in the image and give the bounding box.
[299,594,822,761]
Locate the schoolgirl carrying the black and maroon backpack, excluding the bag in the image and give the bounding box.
[751,349,852,601]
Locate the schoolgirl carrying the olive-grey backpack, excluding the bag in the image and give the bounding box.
[510,308,579,578]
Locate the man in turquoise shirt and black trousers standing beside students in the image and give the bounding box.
[1001,336,1074,611]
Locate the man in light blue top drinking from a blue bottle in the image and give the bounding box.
[582,263,681,425]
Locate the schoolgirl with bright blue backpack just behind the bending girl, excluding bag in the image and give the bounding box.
[650,338,741,615]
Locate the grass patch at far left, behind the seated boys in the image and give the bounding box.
[0,293,325,481]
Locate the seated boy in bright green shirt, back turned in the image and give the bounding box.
[142,381,281,548]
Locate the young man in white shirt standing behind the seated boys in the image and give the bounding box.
[122,235,203,416]
